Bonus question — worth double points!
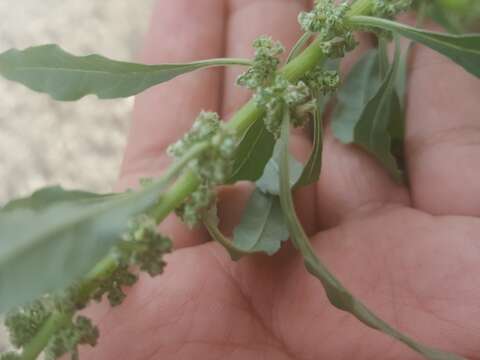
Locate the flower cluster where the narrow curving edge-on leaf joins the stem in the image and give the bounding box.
[254,75,312,138]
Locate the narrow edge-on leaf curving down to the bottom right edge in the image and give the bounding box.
[279,109,463,360]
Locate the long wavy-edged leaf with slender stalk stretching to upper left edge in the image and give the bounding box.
[0,45,250,101]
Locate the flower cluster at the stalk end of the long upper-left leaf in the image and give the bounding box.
[237,36,285,90]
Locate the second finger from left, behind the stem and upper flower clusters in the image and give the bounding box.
[222,0,315,231]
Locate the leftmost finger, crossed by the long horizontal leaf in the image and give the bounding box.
[118,0,226,247]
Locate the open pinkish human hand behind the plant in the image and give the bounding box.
[76,0,480,360]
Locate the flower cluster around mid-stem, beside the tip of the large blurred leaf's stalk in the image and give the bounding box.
[167,111,237,227]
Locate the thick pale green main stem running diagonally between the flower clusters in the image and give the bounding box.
[16,0,380,360]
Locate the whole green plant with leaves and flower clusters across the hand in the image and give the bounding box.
[0,0,480,360]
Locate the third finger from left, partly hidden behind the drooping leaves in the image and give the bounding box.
[317,33,409,229]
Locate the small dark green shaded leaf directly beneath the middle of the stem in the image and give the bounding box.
[229,120,275,183]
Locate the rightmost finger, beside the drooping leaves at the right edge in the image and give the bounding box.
[406,25,480,216]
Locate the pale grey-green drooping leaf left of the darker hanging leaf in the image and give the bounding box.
[332,50,381,144]
